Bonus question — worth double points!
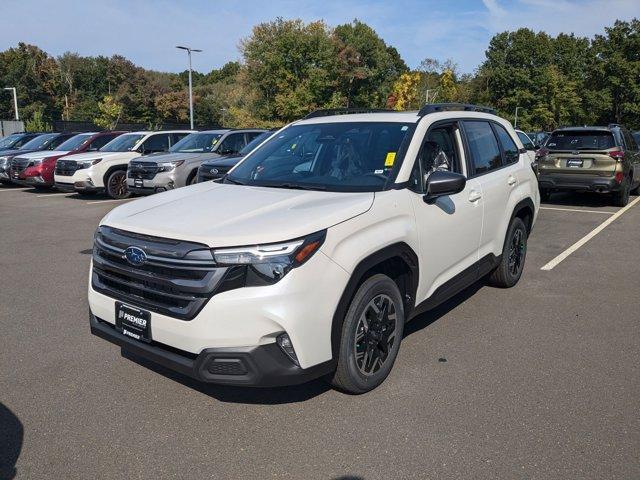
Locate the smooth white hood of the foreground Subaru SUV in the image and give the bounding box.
[101,182,374,247]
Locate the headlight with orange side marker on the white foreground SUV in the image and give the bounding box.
[213,230,327,286]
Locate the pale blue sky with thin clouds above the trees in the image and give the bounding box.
[0,0,640,72]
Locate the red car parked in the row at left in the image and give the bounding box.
[10,131,126,188]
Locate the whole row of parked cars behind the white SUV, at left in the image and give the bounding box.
[0,129,269,199]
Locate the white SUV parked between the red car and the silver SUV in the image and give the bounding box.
[54,130,193,199]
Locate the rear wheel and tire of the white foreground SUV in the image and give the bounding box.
[489,217,527,288]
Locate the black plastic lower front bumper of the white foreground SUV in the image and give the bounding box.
[89,314,335,387]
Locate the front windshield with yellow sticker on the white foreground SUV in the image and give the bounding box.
[227,122,413,192]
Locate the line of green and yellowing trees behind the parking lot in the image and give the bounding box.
[0,18,640,130]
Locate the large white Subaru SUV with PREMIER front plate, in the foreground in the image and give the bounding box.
[89,104,539,393]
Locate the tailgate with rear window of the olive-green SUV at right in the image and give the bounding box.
[540,129,619,177]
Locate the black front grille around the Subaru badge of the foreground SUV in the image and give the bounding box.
[91,226,237,320]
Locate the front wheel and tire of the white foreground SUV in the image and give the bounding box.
[331,274,405,394]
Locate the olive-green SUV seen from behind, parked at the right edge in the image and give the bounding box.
[536,124,640,207]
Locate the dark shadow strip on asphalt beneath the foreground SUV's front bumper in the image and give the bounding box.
[121,350,331,405]
